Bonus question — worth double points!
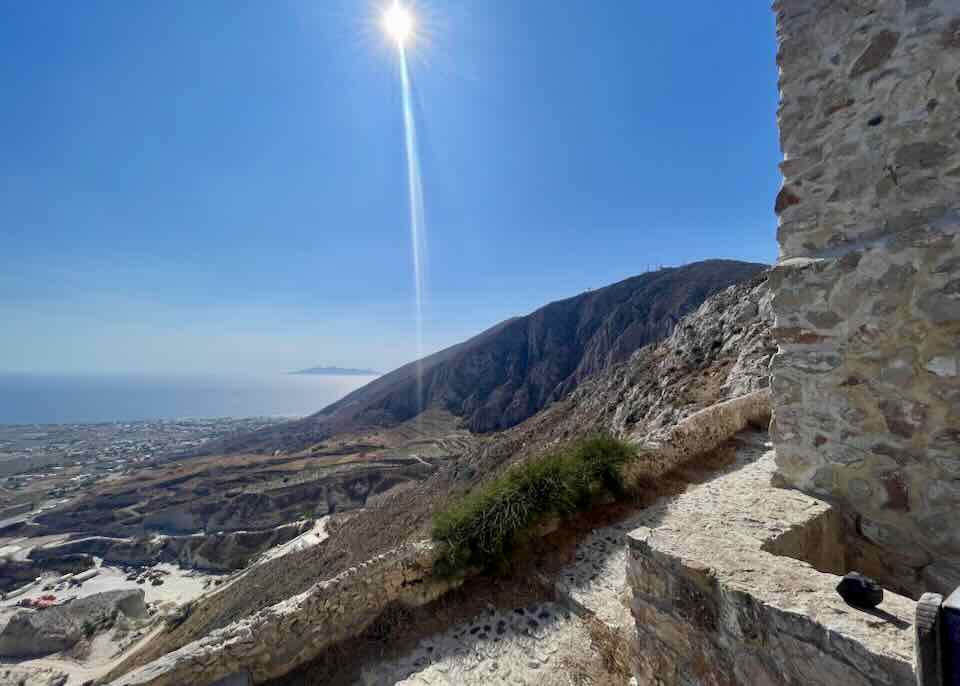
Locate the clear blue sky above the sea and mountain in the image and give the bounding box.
[0,0,780,372]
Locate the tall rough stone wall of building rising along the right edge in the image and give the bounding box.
[771,0,960,591]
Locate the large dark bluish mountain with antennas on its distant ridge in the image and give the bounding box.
[209,260,764,451]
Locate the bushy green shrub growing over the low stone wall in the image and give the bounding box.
[433,435,635,575]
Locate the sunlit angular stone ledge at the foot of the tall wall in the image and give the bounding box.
[627,447,916,686]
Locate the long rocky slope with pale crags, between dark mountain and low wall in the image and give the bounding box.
[122,273,776,664]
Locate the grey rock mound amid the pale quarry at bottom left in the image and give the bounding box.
[0,588,147,657]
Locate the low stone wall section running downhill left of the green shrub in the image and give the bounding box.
[112,542,452,686]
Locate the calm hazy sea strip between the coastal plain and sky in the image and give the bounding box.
[0,374,373,424]
